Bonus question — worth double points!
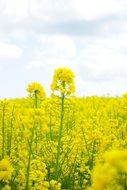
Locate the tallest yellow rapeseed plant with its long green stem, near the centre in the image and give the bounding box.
[51,68,75,180]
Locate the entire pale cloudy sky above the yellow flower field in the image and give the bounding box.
[0,0,127,99]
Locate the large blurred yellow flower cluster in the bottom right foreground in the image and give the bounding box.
[90,150,127,190]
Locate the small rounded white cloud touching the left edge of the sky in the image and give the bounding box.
[0,43,22,57]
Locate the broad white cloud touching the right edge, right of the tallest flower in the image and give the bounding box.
[78,33,127,78]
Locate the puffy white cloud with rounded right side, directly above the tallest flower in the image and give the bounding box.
[26,35,76,69]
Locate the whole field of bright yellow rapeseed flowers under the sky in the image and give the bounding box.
[0,68,127,190]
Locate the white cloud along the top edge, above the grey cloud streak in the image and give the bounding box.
[30,0,127,21]
